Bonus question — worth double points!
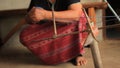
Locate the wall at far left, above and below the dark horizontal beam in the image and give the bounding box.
[0,0,30,39]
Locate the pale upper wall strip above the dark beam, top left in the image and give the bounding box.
[0,0,30,11]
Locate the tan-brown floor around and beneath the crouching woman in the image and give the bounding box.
[0,32,120,68]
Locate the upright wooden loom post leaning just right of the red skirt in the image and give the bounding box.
[88,8,103,68]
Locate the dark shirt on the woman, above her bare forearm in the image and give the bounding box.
[28,0,80,11]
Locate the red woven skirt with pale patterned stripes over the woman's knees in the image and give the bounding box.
[20,14,87,64]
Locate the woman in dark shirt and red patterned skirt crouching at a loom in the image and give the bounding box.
[21,0,87,66]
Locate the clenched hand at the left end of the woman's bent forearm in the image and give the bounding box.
[26,7,46,23]
